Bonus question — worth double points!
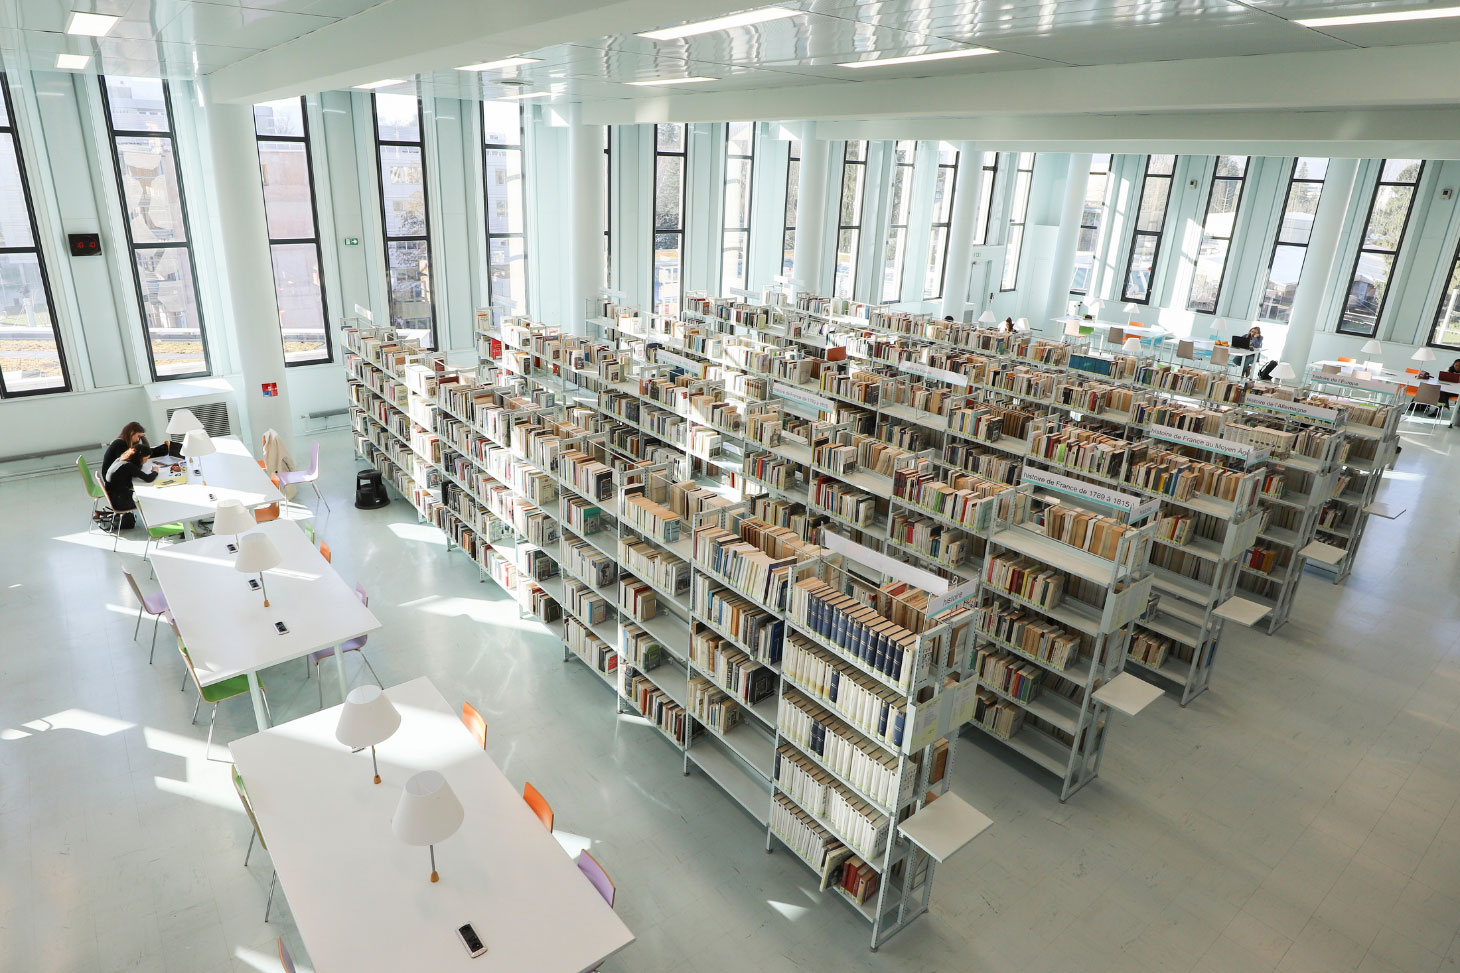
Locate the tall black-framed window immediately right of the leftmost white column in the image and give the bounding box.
[254,98,330,365]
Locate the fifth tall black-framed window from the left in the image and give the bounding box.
[482,101,527,314]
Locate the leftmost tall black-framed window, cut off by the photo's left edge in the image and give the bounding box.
[0,75,72,397]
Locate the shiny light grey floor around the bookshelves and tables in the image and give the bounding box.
[0,430,1460,973]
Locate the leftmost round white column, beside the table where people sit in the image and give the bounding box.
[207,102,299,449]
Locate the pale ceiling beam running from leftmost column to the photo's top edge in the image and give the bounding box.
[209,0,745,104]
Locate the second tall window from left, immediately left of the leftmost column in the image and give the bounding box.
[101,76,212,378]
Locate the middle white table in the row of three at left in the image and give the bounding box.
[149,520,380,729]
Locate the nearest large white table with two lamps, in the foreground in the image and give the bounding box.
[232,678,634,973]
